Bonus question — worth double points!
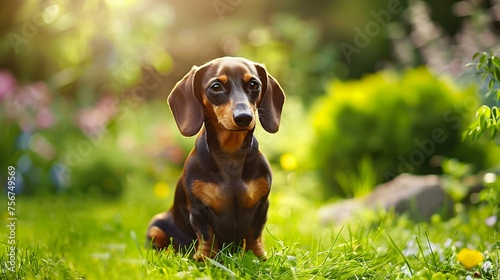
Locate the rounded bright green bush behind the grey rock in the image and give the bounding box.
[309,68,496,194]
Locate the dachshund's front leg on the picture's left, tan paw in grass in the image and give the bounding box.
[189,209,219,261]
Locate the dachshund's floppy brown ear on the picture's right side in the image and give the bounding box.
[255,64,285,133]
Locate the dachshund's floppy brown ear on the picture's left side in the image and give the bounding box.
[168,66,205,136]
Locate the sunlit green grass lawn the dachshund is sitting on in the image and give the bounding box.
[0,172,500,279]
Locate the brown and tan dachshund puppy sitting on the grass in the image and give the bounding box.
[147,57,285,260]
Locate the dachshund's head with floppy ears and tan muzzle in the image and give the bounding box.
[168,57,285,136]
